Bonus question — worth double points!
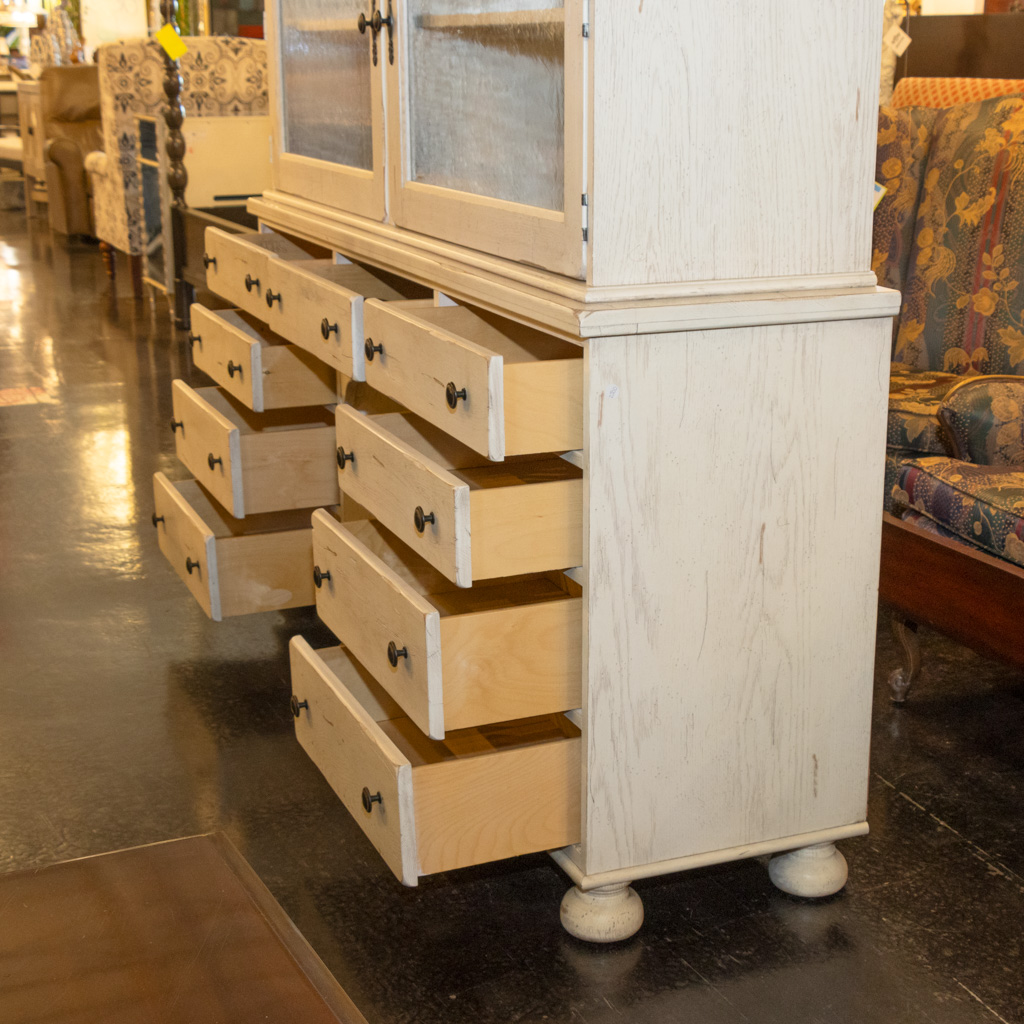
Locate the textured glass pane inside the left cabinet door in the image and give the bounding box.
[281,0,373,170]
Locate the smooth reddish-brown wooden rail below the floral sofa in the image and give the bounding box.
[879,513,1024,668]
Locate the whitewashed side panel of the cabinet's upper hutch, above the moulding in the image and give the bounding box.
[590,0,882,286]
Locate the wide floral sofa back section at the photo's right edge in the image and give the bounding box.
[895,97,1024,374]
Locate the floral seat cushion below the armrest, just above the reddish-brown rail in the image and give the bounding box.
[897,457,1024,565]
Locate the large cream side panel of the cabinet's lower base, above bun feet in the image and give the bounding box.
[584,319,891,873]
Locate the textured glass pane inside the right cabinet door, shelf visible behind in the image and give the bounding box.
[407,0,565,210]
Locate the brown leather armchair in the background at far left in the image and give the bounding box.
[39,65,100,234]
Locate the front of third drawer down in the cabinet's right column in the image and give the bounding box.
[313,511,444,736]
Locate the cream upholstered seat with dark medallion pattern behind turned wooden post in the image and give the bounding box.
[86,36,268,292]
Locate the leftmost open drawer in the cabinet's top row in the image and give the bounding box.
[204,227,312,316]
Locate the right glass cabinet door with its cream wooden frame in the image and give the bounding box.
[382,0,586,276]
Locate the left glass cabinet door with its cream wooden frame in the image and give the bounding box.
[267,0,385,219]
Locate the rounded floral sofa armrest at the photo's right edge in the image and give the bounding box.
[938,375,1024,466]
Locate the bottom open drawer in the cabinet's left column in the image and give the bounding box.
[153,473,313,622]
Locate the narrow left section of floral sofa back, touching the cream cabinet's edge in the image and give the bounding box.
[871,106,938,311]
